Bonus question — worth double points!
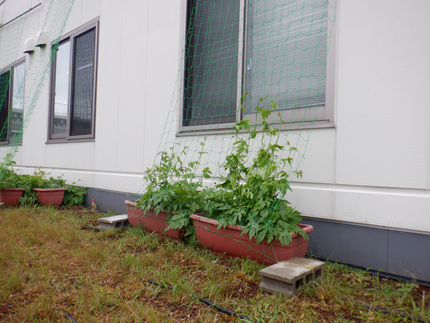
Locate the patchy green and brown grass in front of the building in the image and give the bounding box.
[0,208,430,323]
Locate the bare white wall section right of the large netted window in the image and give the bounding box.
[291,0,430,231]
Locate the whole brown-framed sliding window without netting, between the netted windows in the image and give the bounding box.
[49,22,98,141]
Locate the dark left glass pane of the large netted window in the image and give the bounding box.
[183,0,240,126]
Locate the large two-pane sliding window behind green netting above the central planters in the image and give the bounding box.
[180,0,333,131]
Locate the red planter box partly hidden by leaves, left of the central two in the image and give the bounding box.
[124,200,182,240]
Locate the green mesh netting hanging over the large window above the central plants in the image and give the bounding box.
[140,0,336,264]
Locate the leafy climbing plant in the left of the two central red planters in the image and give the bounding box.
[137,142,211,235]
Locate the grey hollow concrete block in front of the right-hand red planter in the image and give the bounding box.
[260,257,325,296]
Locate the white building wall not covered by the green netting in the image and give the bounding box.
[0,0,430,232]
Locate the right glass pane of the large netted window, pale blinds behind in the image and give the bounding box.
[245,0,327,119]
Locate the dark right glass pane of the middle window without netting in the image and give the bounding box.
[70,29,95,136]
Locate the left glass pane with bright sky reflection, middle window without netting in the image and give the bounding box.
[51,41,70,134]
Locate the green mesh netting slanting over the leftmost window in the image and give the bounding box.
[0,0,74,159]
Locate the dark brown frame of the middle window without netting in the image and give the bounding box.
[47,18,100,143]
